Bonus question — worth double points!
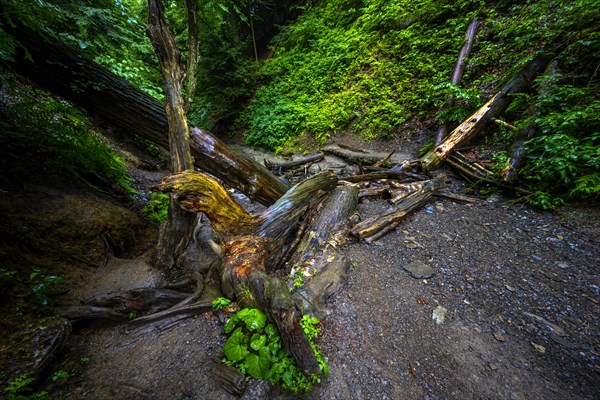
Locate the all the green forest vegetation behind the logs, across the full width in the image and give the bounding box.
[0,0,600,209]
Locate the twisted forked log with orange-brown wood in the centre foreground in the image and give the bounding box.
[152,171,337,373]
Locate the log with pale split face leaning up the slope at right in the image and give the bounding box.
[421,54,549,171]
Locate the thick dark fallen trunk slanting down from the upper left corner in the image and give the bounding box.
[3,21,289,206]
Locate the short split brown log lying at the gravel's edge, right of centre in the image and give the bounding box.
[351,180,441,240]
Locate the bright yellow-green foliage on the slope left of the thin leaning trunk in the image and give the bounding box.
[244,0,488,148]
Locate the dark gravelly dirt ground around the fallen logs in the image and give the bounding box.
[0,135,600,400]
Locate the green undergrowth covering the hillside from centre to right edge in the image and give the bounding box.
[241,0,600,208]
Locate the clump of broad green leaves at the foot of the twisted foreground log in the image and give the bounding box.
[223,308,329,394]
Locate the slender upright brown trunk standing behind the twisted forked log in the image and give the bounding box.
[147,0,197,269]
